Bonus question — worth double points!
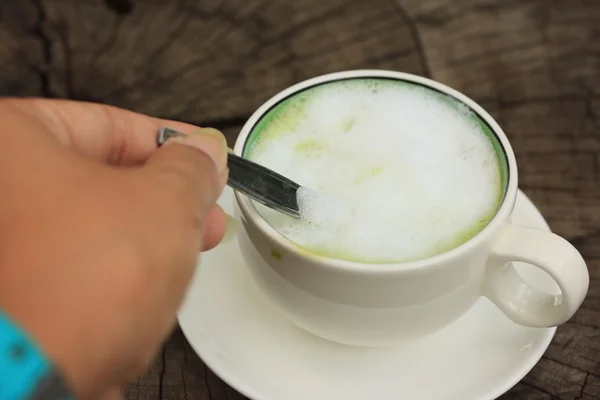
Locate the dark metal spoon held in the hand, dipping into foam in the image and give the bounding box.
[156,128,300,218]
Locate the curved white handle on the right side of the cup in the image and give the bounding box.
[484,223,590,328]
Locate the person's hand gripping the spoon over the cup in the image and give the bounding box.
[0,99,228,399]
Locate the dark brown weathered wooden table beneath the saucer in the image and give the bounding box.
[0,0,600,400]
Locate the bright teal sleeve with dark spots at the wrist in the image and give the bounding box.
[0,311,74,400]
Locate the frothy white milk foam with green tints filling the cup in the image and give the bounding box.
[249,80,502,262]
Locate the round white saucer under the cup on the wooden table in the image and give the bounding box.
[179,188,556,400]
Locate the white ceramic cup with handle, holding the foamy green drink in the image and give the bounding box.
[234,70,589,346]
